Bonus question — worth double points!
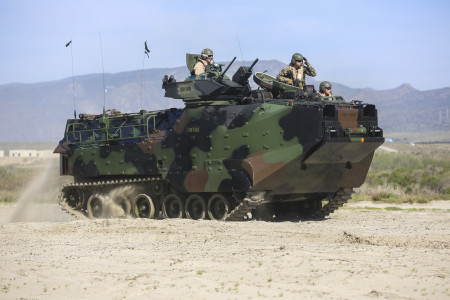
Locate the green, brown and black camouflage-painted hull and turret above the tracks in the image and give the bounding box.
[55,72,384,207]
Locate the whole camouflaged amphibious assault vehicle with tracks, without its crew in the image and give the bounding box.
[55,54,384,220]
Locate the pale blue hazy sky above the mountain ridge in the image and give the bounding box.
[0,0,450,90]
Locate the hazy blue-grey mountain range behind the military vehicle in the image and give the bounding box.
[0,60,450,142]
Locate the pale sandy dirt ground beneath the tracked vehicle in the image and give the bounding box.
[0,201,450,299]
